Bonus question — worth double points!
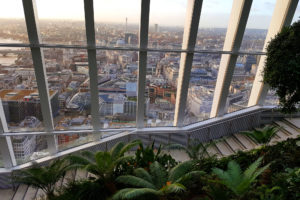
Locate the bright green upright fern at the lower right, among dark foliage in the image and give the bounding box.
[213,157,269,196]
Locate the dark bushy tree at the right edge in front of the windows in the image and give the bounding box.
[263,21,300,113]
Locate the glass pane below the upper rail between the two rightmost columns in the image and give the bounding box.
[225,55,260,113]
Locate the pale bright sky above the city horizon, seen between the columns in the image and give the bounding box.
[0,0,300,29]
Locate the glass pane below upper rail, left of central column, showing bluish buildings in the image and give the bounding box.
[97,51,138,128]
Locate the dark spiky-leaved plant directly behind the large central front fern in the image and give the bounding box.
[134,142,177,168]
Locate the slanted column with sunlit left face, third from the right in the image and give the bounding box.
[174,0,202,126]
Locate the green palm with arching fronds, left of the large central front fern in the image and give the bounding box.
[67,141,140,194]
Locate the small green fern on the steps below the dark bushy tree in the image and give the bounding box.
[242,126,279,145]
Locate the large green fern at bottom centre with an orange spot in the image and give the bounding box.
[113,161,205,200]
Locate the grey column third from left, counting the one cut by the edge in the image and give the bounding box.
[84,0,101,130]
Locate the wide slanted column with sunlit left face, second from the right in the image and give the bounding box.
[210,0,252,117]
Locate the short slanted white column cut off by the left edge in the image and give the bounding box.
[0,99,17,168]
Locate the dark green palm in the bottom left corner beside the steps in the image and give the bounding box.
[13,160,69,200]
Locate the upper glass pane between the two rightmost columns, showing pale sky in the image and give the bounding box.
[240,0,276,51]
